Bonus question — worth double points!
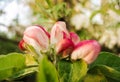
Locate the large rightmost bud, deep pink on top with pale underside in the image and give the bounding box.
[71,40,100,64]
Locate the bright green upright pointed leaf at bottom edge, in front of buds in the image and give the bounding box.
[37,57,58,82]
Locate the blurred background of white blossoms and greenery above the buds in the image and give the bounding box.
[0,0,120,55]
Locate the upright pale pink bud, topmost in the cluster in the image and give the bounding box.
[50,21,70,44]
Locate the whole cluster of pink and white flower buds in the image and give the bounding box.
[19,21,100,64]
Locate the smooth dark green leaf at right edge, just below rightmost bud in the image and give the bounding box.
[90,52,120,71]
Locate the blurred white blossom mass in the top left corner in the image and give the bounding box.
[0,0,33,38]
